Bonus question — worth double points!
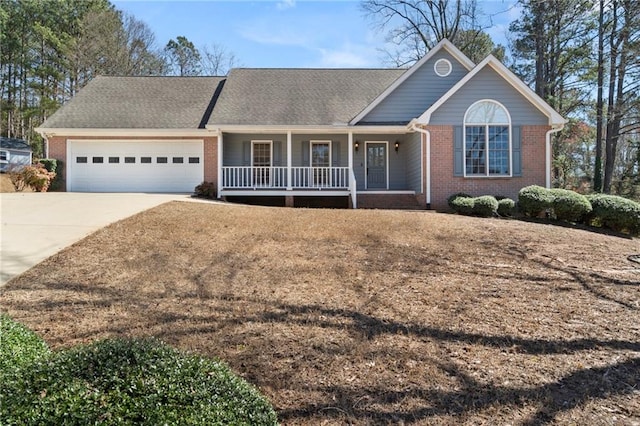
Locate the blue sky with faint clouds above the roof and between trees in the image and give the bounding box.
[113,0,519,68]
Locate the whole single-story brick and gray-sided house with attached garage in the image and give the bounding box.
[38,40,565,208]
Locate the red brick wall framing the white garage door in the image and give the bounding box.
[43,136,218,191]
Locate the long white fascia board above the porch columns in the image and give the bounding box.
[210,125,410,135]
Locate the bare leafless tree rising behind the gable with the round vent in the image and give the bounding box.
[361,0,495,67]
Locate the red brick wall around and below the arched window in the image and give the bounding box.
[428,126,549,210]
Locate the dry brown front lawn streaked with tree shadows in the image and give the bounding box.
[0,202,640,425]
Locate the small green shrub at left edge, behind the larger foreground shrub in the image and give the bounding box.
[0,314,50,380]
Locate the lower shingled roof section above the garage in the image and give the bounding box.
[40,77,225,129]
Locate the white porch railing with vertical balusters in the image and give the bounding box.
[222,166,350,189]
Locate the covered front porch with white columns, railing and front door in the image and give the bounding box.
[218,132,423,208]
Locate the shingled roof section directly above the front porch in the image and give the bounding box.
[208,68,405,126]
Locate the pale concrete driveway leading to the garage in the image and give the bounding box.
[0,192,190,287]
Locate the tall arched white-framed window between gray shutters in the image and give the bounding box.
[464,100,511,176]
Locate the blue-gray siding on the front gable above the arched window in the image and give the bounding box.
[429,67,549,126]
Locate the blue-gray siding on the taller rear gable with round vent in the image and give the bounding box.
[360,50,468,123]
